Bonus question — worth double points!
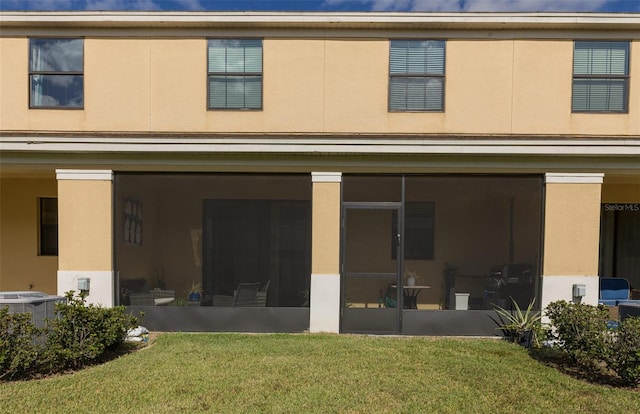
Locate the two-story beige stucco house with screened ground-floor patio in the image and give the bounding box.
[0,12,640,335]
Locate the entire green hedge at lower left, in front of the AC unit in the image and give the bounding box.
[0,291,138,379]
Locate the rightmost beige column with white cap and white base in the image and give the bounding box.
[540,173,604,309]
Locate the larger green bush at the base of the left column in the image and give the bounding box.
[43,291,138,372]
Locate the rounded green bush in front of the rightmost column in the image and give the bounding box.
[546,300,611,370]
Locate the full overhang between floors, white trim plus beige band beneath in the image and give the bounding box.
[0,131,640,176]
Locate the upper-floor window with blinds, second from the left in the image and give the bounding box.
[207,39,262,109]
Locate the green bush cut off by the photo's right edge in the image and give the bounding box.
[607,317,640,385]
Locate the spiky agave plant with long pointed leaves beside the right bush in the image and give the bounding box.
[494,298,542,348]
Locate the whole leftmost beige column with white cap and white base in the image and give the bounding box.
[56,170,114,307]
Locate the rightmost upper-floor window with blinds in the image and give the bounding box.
[572,41,629,112]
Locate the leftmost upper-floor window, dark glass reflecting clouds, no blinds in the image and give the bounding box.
[29,39,84,109]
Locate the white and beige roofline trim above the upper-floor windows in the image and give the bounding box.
[0,11,640,39]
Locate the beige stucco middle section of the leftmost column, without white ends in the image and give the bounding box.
[58,180,113,271]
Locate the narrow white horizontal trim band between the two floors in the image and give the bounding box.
[0,131,640,158]
